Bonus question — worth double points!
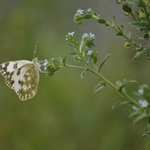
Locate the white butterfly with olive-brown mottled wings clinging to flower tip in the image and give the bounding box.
[0,58,41,101]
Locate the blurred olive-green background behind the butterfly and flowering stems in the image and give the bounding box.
[0,0,150,150]
